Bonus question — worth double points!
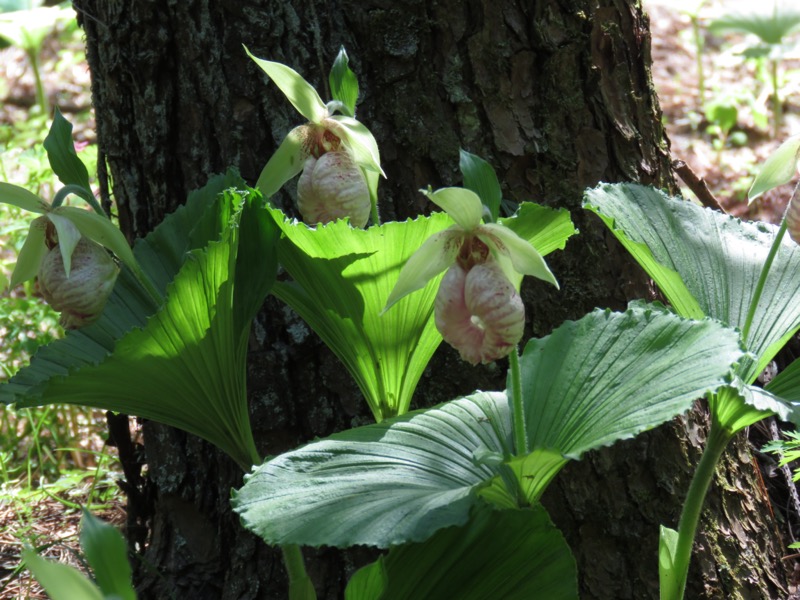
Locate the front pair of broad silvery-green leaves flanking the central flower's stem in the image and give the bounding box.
[234,306,742,547]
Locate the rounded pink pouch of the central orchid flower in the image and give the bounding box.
[434,261,525,365]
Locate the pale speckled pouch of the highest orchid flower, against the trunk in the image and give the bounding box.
[297,150,371,227]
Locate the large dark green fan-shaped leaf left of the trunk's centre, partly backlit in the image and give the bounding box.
[0,175,277,465]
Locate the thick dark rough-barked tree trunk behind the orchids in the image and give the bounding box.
[74,0,785,599]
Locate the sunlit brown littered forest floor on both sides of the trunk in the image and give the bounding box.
[0,0,800,598]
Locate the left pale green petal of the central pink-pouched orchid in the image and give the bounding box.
[382,227,464,313]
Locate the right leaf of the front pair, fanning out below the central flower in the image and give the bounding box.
[512,305,744,501]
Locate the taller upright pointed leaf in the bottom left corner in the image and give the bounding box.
[80,509,136,600]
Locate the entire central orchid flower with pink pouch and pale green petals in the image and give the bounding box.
[384,188,558,364]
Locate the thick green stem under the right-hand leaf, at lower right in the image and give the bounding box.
[664,420,732,600]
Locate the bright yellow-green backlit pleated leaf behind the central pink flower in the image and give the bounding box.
[272,205,575,421]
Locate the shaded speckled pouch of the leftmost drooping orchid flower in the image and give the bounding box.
[39,238,119,329]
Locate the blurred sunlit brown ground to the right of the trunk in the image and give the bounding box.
[643,0,800,223]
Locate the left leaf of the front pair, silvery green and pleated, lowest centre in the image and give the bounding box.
[233,393,511,548]
